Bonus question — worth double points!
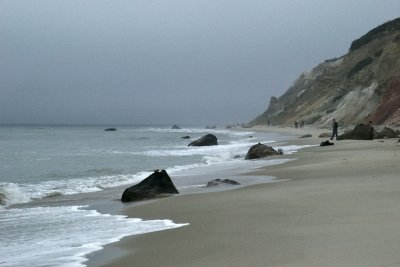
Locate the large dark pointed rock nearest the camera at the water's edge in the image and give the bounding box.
[121,170,179,202]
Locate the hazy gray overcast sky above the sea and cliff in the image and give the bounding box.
[0,0,400,125]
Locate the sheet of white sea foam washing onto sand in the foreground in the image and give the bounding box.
[0,206,187,267]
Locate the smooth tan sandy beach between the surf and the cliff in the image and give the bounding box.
[88,128,400,267]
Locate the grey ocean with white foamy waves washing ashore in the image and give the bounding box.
[0,126,300,267]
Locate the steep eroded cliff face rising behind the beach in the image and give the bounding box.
[251,18,400,126]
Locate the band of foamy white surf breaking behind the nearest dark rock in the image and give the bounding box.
[0,142,308,208]
